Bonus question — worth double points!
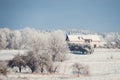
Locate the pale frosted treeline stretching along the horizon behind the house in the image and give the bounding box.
[0,28,120,49]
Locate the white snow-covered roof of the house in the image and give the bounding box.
[68,35,100,41]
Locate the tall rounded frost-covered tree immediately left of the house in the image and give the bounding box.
[48,30,68,61]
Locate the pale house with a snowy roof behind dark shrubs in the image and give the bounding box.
[66,35,100,48]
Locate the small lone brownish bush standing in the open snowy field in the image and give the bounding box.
[72,63,89,77]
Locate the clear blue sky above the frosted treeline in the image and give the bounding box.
[0,0,120,32]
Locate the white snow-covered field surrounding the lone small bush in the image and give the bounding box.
[0,49,120,80]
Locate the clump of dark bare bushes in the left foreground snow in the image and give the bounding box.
[8,51,65,73]
